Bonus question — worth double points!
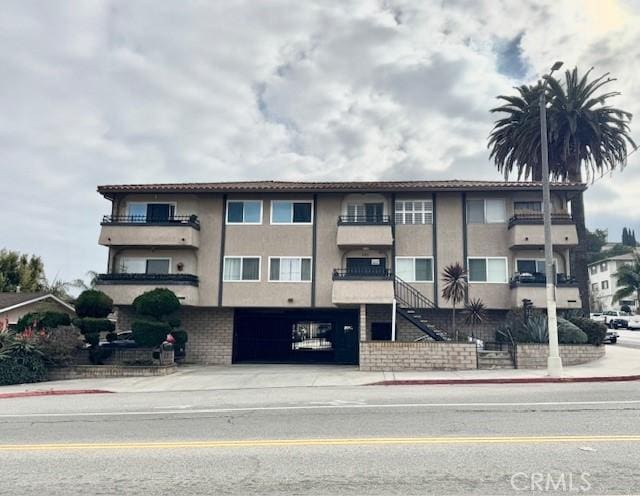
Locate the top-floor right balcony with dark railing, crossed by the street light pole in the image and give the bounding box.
[509,213,578,249]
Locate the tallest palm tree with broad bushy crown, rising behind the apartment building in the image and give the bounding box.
[488,68,637,315]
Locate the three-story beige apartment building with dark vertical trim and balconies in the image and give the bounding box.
[98,181,584,364]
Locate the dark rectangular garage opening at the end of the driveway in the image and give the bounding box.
[233,309,359,364]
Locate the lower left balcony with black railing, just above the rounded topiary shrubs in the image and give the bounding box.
[96,274,199,305]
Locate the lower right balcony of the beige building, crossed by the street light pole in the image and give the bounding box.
[510,273,581,309]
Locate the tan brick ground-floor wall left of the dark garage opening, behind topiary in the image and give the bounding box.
[117,306,233,365]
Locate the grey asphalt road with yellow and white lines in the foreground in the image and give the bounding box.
[0,383,640,495]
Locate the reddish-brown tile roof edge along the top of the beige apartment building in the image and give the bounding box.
[98,179,586,196]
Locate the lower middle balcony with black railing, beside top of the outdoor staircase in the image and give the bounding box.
[331,269,394,305]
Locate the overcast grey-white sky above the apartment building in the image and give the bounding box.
[0,0,640,286]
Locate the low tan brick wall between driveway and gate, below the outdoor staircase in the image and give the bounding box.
[360,341,478,371]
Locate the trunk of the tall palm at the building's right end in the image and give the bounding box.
[568,164,591,317]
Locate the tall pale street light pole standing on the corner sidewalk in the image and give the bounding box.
[539,62,562,377]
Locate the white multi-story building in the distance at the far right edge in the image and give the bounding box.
[589,253,638,311]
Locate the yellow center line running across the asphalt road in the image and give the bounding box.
[0,435,640,451]
